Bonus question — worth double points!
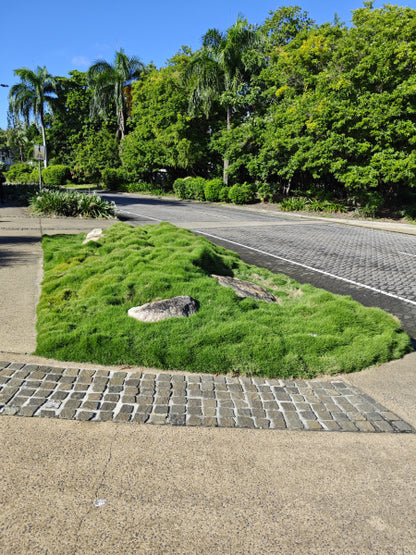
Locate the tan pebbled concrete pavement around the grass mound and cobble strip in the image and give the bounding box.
[0,202,416,554]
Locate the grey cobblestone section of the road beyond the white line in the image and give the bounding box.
[207,223,416,301]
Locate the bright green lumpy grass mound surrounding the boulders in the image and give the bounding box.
[36,223,411,378]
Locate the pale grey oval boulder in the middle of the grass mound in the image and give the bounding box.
[127,295,199,322]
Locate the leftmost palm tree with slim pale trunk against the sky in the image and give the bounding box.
[9,66,57,168]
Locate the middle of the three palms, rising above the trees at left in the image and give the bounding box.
[88,49,144,139]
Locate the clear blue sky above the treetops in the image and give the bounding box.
[0,0,416,129]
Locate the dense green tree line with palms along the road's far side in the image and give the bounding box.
[3,1,416,215]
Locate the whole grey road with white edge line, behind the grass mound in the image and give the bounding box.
[105,194,416,340]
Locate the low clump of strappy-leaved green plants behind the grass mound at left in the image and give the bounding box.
[30,189,115,218]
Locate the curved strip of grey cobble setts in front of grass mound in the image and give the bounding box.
[0,361,415,433]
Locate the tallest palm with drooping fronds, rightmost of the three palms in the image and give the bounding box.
[187,16,261,183]
